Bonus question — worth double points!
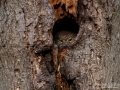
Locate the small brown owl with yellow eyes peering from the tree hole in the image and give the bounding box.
[54,31,77,46]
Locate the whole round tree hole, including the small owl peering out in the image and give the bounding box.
[53,17,79,46]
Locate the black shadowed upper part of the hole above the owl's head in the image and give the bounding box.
[53,17,79,36]
